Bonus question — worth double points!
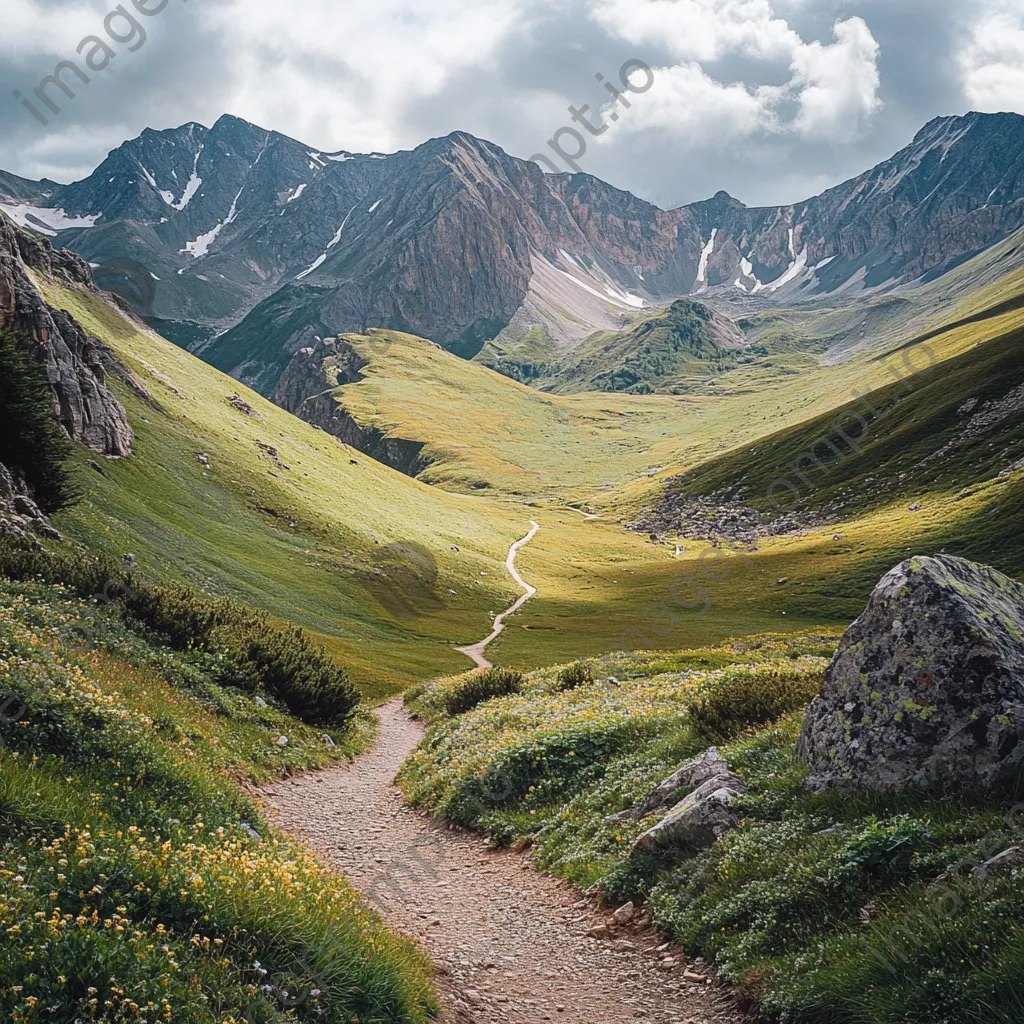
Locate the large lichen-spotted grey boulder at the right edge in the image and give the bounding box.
[798,555,1024,791]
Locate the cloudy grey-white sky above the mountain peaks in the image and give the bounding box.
[0,0,1024,207]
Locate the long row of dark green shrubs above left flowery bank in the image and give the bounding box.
[0,542,359,729]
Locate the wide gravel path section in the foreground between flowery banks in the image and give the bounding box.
[261,700,742,1024]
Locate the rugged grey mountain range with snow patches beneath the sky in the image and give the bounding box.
[0,114,1024,393]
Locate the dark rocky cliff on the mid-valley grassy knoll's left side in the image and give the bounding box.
[273,338,429,476]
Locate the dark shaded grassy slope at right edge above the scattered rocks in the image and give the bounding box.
[675,321,1024,573]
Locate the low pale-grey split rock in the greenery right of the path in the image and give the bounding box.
[618,746,746,857]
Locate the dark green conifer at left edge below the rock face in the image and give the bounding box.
[0,331,77,514]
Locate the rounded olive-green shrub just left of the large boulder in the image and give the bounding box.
[687,662,821,740]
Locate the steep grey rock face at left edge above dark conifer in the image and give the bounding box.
[0,216,132,456]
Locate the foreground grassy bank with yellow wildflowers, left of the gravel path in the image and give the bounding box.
[0,584,436,1024]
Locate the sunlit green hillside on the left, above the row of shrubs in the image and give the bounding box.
[32,272,528,695]
